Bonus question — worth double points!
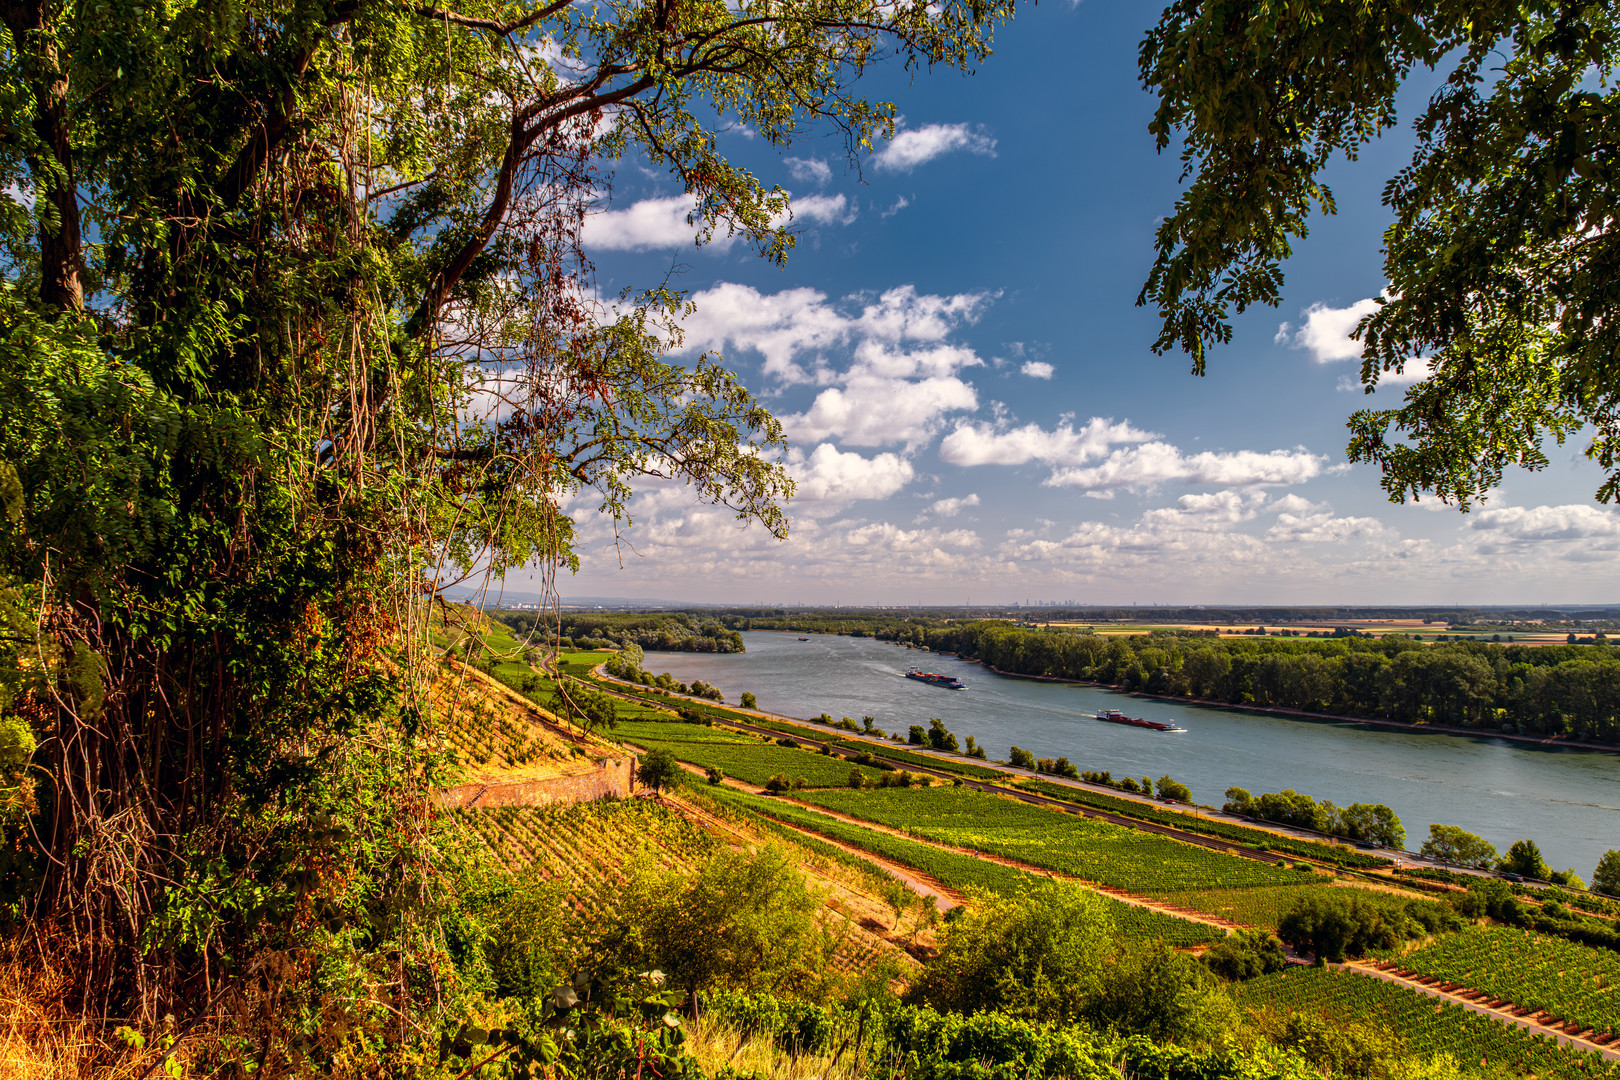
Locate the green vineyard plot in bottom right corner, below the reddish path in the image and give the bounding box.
[1233,967,1620,1080]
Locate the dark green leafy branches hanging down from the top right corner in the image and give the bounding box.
[1137,0,1620,508]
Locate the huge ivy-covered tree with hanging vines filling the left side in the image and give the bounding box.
[0,0,1011,1061]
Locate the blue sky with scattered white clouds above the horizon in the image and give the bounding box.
[509,3,1620,604]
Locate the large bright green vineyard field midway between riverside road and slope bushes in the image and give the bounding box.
[804,787,1304,895]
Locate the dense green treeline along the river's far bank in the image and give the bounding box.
[907,622,1620,743]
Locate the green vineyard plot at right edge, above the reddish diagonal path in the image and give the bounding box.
[1395,926,1620,1031]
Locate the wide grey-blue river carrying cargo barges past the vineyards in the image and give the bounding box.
[646,630,1620,881]
